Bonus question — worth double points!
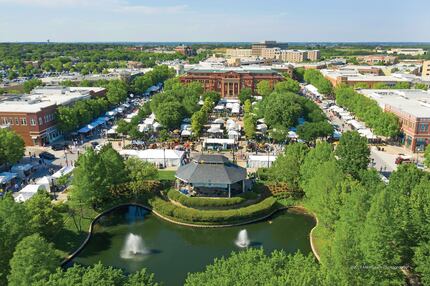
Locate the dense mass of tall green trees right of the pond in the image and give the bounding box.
[269,132,430,285]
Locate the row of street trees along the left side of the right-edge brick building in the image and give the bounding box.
[335,86,400,137]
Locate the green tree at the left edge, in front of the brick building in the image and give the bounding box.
[0,128,25,165]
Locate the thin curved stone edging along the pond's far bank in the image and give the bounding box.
[61,203,320,267]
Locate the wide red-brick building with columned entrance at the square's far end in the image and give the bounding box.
[180,67,283,98]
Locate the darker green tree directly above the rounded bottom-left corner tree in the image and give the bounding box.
[24,190,64,240]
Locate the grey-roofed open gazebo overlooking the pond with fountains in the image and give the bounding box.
[176,155,247,197]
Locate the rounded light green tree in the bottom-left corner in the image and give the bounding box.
[8,234,60,286]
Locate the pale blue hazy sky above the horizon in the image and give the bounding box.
[0,0,430,42]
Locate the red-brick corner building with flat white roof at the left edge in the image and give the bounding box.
[0,88,104,146]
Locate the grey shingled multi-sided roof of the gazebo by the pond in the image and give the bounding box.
[176,155,246,185]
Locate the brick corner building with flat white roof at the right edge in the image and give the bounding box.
[359,89,430,152]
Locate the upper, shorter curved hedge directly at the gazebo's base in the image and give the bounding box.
[167,189,258,208]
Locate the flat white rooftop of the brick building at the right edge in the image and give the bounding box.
[359,89,430,118]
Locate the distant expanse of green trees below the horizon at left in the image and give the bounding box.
[0,44,186,79]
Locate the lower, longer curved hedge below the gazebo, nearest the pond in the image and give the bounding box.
[149,196,278,224]
